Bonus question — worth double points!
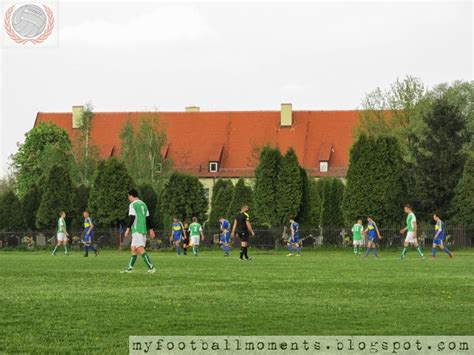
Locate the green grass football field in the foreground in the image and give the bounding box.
[0,249,474,353]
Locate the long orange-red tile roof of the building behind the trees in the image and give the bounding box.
[35,111,358,177]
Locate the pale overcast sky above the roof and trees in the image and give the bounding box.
[0,1,474,175]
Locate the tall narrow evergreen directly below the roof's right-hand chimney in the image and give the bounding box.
[276,148,302,225]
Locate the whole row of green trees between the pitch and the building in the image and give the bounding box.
[0,77,474,231]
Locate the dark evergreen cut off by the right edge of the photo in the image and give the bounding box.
[451,153,474,226]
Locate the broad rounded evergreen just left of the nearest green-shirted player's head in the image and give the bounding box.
[89,158,134,226]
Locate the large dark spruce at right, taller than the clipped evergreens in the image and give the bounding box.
[410,91,470,218]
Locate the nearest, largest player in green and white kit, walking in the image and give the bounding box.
[123,189,156,274]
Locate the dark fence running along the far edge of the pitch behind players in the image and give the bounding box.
[0,226,474,249]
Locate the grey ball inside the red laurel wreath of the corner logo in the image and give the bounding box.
[12,4,47,38]
